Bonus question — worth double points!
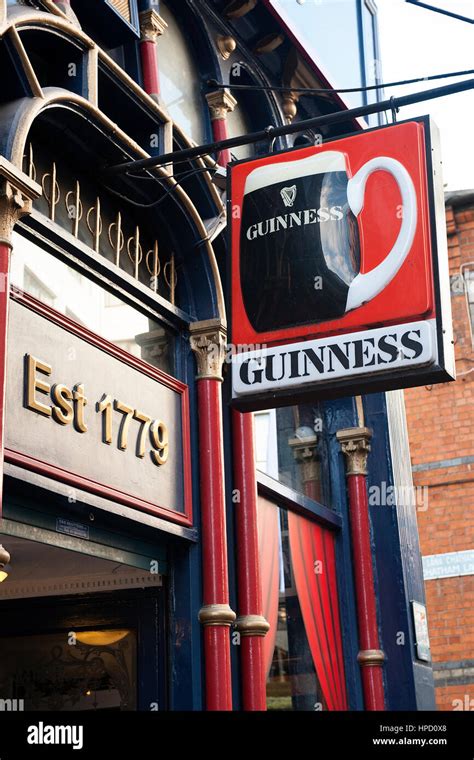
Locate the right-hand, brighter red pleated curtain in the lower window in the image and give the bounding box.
[288,512,347,710]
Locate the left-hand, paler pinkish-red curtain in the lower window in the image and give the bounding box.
[258,496,280,678]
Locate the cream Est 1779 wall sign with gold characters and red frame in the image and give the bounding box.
[5,295,191,524]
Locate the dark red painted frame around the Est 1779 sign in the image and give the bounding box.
[5,287,192,526]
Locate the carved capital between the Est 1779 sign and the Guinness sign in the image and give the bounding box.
[189,319,227,381]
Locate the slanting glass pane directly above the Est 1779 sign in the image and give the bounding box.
[11,232,174,374]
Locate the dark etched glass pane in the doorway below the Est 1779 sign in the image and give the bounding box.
[0,629,137,711]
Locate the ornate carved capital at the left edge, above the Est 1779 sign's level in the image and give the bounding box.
[0,156,42,246]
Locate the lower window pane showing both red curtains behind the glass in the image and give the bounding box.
[258,497,347,711]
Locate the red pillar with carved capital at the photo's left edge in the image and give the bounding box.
[0,156,41,515]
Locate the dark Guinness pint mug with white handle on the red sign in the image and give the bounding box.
[240,151,417,332]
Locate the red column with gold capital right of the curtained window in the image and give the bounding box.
[336,427,385,710]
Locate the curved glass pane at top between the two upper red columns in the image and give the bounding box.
[158,2,207,144]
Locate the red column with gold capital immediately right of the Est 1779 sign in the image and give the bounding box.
[190,319,235,710]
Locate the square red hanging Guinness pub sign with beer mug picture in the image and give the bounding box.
[228,117,454,411]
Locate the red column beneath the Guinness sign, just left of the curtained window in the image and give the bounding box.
[232,410,270,710]
